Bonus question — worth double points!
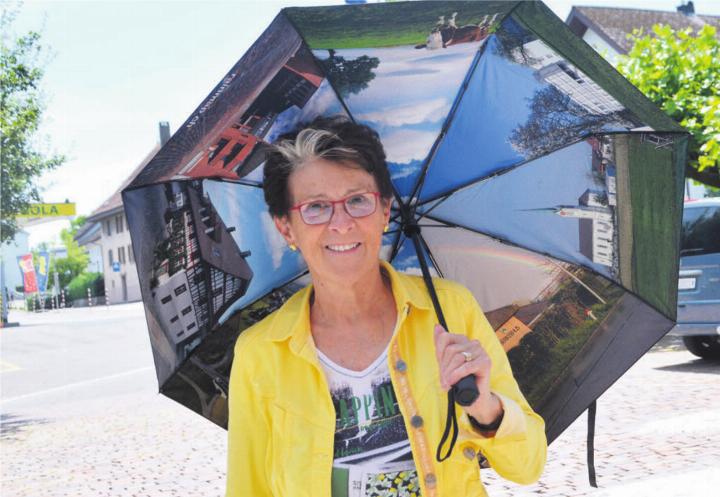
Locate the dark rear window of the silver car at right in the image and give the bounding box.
[680,206,720,256]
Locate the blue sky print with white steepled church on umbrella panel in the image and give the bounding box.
[424,138,618,280]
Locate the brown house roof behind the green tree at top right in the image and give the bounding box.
[565,6,720,53]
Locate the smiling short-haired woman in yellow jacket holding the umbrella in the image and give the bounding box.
[227,118,547,497]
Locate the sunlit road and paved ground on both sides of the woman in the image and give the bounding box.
[0,304,720,497]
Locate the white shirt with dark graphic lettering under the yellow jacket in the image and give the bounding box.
[318,351,420,497]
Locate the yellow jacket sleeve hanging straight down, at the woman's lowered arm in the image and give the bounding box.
[225,334,271,497]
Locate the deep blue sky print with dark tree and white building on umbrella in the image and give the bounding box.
[420,18,642,201]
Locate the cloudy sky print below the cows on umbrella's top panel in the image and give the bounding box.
[313,38,483,196]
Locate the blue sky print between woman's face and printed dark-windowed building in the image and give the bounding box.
[203,180,305,320]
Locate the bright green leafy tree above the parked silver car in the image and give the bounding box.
[617,24,720,188]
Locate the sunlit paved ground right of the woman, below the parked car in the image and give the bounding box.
[483,339,720,497]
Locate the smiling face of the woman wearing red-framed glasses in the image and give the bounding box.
[275,159,390,285]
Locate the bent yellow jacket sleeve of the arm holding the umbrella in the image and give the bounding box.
[457,288,547,485]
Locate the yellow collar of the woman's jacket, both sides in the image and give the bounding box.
[268,260,432,353]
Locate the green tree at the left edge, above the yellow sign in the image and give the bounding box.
[0,9,65,243]
